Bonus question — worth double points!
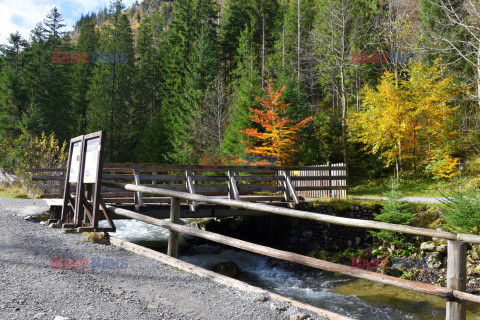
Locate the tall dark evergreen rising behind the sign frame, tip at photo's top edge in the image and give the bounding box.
[87,1,135,162]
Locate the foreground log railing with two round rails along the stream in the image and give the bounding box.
[103,181,480,320]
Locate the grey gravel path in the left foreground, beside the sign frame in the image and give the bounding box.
[0,198,326,320]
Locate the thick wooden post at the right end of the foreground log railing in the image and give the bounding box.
[445,240,467,320]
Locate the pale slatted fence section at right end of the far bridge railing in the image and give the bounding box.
[290,162,347,198]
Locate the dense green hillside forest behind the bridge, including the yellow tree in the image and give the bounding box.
[0,0,480,178]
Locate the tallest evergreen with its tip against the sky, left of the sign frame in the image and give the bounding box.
[22,8,73,140]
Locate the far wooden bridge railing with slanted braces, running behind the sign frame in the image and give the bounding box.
[27,164,347,205]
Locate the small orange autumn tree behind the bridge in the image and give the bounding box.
[239,80,313,165]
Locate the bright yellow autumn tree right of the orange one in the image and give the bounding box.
[349,60,463,176]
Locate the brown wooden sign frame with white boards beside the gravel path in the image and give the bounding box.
[55,131,116,232]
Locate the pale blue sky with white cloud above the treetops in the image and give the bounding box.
[0,0,137,44]
